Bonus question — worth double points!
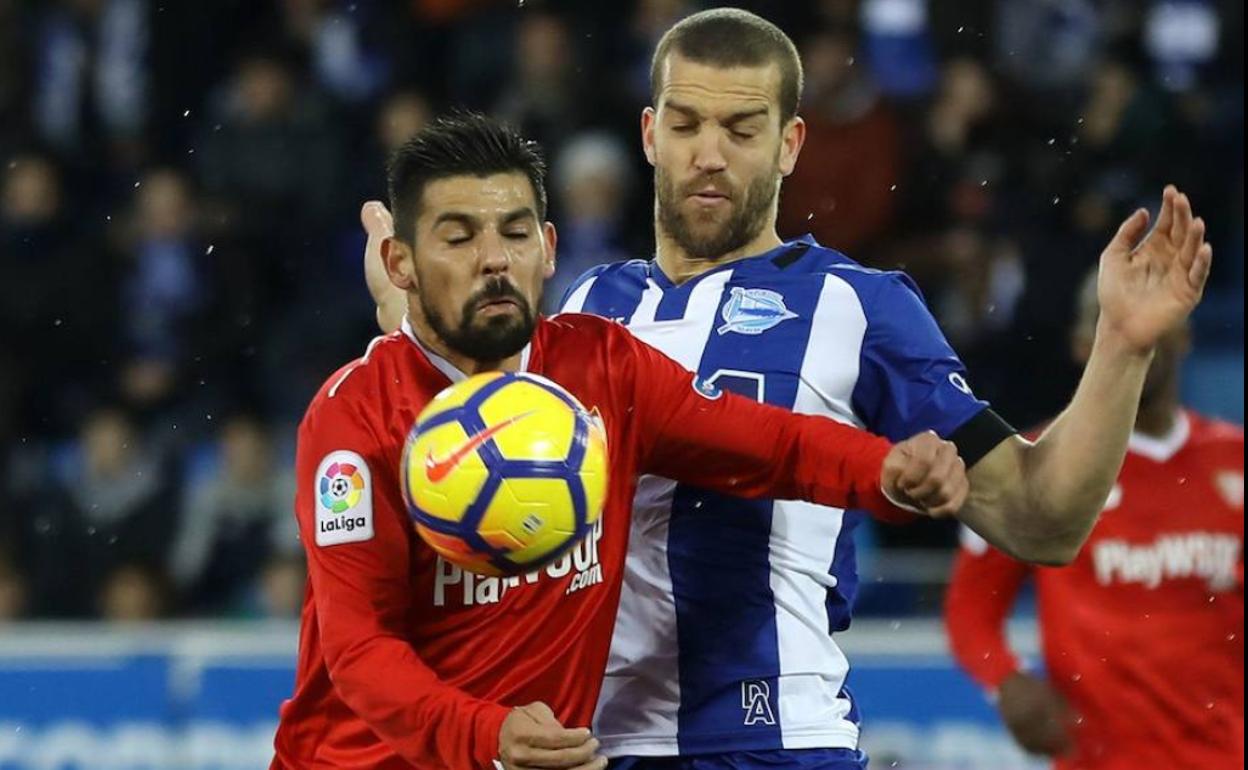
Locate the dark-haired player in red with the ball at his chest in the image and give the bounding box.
[273,116,967,770]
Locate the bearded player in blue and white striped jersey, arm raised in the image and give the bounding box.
[364,9,1212,770]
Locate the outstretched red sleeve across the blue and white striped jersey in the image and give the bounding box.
[628,324,914,522]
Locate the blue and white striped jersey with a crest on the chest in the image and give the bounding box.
[563,237,987,756]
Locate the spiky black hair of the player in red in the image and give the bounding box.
[387,111,547,243]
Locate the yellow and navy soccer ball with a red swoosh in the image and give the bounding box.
[399,372,607,575]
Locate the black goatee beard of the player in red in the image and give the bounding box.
[419,278,537,362]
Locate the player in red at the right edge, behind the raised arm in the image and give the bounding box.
[946,268,1244,770]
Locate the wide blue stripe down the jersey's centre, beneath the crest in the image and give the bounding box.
[668,272,822,754]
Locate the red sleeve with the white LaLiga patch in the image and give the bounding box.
[296,397,509,768]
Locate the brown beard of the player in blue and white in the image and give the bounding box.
[654,160,779,261]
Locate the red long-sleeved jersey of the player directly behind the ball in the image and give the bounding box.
[273,314,906,770]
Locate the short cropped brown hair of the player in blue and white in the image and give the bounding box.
[650,7,802,126]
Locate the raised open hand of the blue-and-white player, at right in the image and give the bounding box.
[1097,185,1213,352]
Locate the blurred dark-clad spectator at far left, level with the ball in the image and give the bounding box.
[20,408,176,616]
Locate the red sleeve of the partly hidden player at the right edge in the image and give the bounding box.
[945,533,1031,690]
